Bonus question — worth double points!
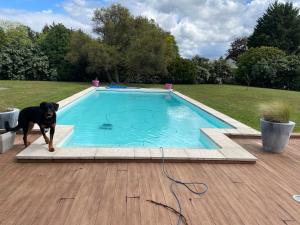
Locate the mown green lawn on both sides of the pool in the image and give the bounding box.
[0,81,300,132]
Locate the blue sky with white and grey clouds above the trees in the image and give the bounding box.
[0,0,300,59]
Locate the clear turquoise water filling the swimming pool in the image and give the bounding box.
[58,91,231,149]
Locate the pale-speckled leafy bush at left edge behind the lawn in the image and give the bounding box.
[0,43,56,80]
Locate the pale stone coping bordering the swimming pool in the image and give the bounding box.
[16,87,260,163]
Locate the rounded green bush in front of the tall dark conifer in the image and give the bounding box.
[237,47,286,87]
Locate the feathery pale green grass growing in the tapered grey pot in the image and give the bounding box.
[260,102,291,123]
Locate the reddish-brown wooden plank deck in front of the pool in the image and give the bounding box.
[0,134,300,225]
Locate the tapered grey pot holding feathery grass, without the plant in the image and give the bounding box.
[260,119,295,153]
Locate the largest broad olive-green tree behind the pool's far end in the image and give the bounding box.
[93,5,178,82]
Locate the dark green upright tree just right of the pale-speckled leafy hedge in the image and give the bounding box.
[39,24,71,80]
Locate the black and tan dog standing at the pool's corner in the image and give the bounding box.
[5,102,59,152]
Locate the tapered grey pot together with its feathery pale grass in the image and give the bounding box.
[260,102,295,153]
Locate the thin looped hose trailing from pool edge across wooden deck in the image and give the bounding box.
[147,147,208,225]
